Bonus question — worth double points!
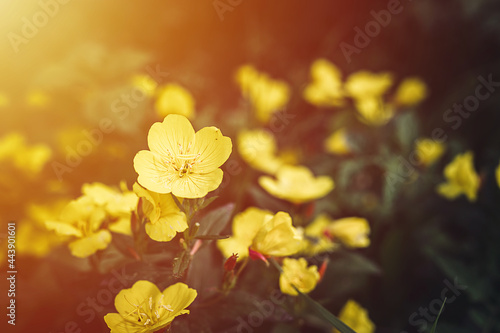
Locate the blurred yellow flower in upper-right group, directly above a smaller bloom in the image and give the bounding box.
[345,71,392,100]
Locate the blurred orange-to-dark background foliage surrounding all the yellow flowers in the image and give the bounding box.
[0,0,500,333]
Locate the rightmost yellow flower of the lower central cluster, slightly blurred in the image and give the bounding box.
[327,217,370,248]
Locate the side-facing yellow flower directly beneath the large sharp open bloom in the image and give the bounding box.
[134,183,188,242]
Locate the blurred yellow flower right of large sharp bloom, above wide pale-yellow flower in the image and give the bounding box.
[238,129,283,175]
